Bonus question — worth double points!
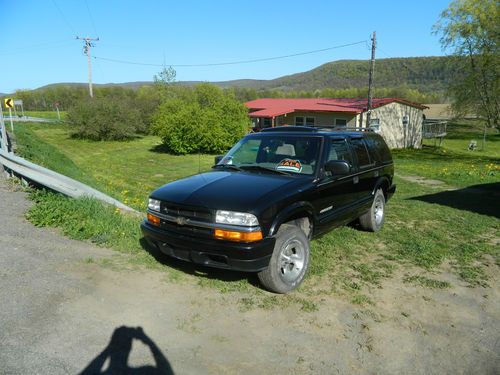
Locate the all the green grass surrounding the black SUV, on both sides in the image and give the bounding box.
[9,118,500,310]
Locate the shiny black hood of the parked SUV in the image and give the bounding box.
[151,171,309,212]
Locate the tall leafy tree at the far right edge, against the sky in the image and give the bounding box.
[433,0,500,127]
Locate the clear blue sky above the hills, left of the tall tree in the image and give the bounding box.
[0,0,449,93]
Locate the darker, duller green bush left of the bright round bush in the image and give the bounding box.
[67,97,146,141]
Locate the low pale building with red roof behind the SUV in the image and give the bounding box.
[245,98,427,148]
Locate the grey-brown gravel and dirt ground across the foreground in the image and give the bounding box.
[0,177,500,374]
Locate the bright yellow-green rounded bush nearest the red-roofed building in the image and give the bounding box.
[152,83,250,155]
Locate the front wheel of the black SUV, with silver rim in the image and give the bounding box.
[258,224,310,294]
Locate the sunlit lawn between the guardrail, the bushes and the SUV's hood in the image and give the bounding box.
[14,123,214,210]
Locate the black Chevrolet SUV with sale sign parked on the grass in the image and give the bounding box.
[141,126,396,293]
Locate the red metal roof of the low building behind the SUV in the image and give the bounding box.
[245,98,427,117]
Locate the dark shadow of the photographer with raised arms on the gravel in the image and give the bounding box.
[80,326,174,375]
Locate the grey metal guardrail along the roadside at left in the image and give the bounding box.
[0,114,139,214]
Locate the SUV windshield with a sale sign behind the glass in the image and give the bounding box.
[217,134,321,175]
